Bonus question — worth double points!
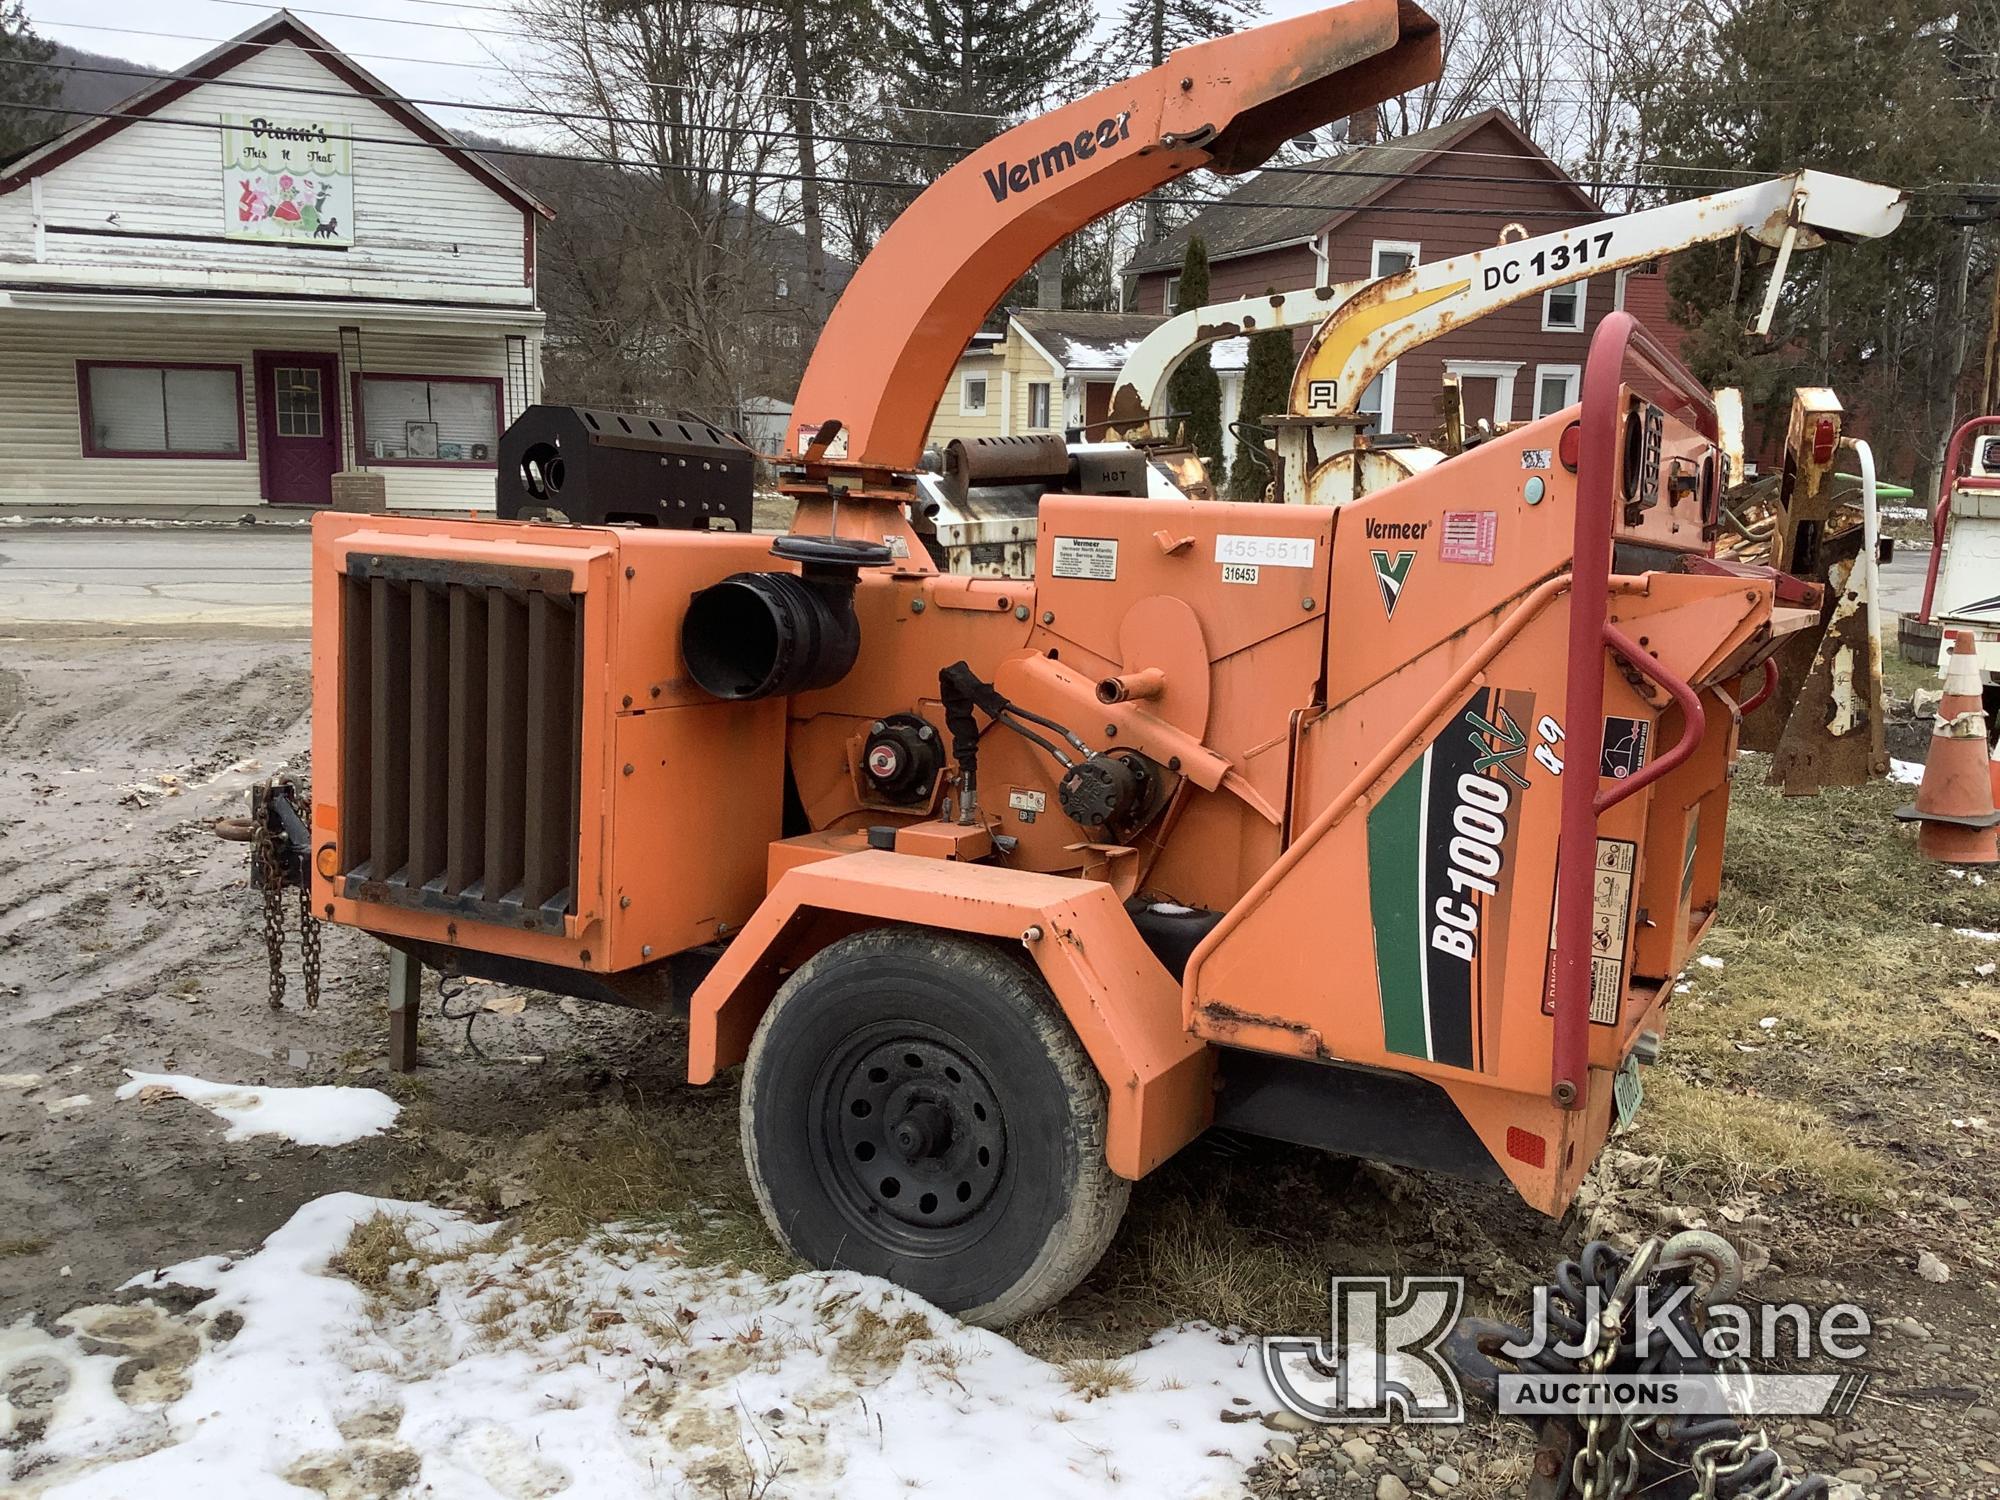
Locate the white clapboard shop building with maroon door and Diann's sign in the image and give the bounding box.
[0,10,548,512]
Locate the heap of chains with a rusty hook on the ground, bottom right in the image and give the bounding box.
[1448,1230,1828,1500]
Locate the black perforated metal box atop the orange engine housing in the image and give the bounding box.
[494,406,756,532]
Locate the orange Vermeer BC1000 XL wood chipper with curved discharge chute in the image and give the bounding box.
[262,0,1810,1322]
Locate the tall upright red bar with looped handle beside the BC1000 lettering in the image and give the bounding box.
[1550,312,1716,1110]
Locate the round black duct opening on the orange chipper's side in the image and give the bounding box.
[680,536,890,702]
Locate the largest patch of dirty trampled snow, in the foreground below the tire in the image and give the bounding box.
[15,1194,1376,1500]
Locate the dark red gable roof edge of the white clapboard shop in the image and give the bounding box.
[0,10,556,218]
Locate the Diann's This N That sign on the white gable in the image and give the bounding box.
[222,114,354,246]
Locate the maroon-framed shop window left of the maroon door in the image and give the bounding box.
[76,362,244,458]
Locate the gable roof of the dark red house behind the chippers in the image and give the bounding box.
[1124,110,1602,276]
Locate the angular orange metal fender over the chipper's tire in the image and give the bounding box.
[688,850,1214,1178]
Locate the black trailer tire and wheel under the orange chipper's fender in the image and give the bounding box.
[742,926,1130,1326]
